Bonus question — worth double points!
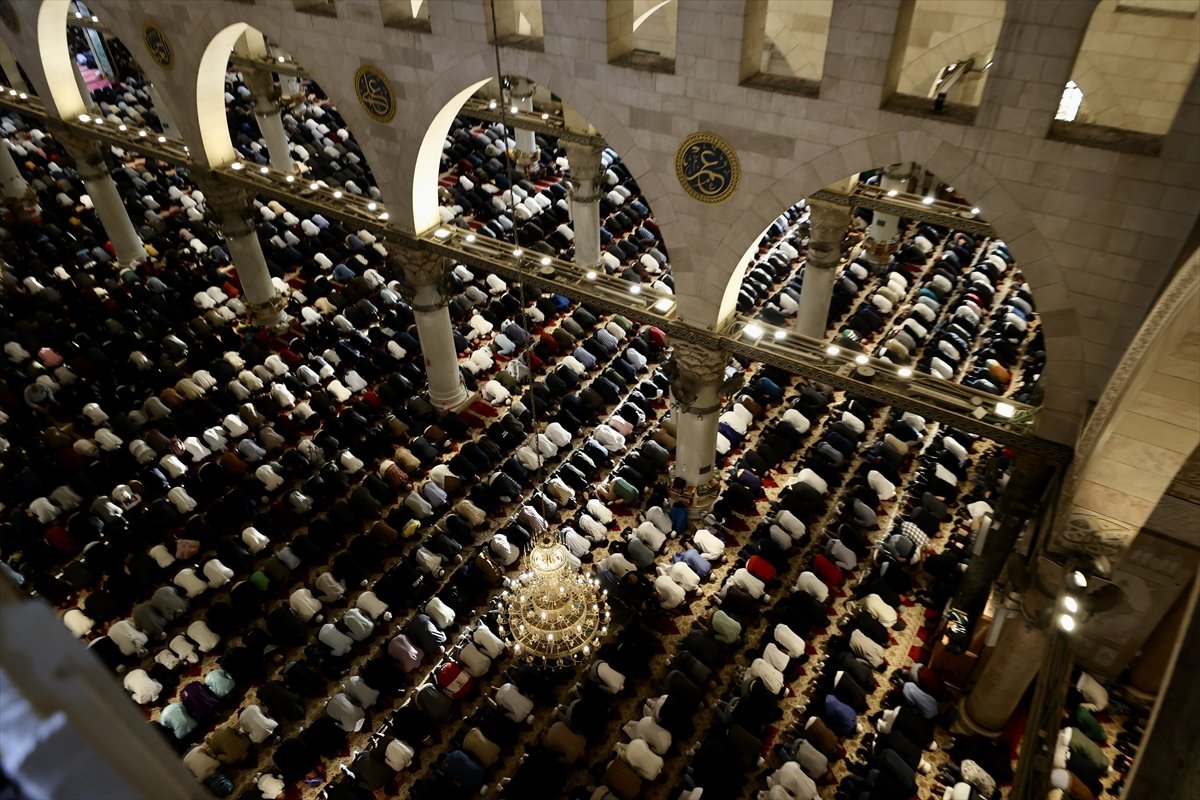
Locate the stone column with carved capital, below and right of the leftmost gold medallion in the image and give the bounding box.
[201,176,288,327]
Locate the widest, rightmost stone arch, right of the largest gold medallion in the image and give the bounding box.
[697,131,1084,443]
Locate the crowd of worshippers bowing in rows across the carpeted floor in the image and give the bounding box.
[0,51,1128,800]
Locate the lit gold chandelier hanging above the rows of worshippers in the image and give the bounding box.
[499,536,610,669]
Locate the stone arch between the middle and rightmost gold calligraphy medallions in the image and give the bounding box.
[403,49,672,235]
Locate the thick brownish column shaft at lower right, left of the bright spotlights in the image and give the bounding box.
[958,614,1046,736]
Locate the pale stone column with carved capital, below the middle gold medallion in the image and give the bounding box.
[389,242,470,411]
